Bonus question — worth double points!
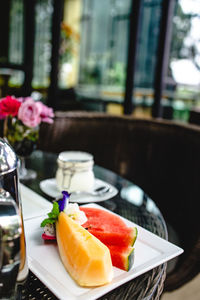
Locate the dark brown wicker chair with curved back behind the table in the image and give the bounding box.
[39,112,200,291]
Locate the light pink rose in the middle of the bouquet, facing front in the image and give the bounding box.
[18,98,41,127]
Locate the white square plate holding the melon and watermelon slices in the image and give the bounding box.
[22,188,183,300]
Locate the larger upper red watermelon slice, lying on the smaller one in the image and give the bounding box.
[80,207,137,246]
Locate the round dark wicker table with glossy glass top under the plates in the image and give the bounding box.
[19,151,167,300]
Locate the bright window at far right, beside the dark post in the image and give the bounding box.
[168,0,200,121]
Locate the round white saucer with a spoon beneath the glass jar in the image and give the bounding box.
[40,178,118,203]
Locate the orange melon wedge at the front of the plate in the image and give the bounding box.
[56,212,113,286]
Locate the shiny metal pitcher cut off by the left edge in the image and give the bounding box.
[0,138,28,299]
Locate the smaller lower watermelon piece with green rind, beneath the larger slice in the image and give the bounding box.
[107,245,134,271]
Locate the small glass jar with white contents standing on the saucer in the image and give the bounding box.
[56,151,94,193]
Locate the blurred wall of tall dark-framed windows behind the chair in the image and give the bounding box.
[0,0,200,123]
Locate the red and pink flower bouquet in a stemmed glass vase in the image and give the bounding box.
[0,96,54,180]
